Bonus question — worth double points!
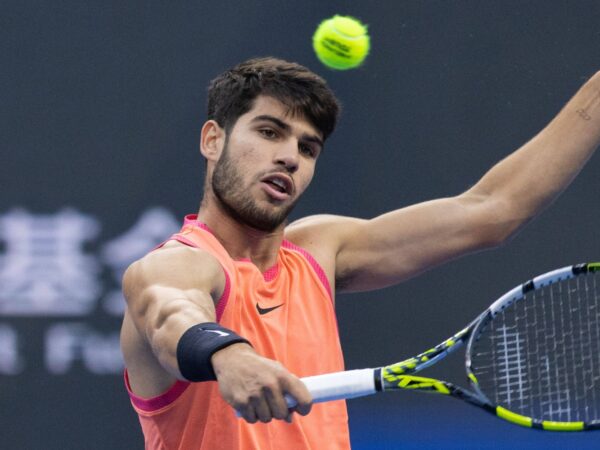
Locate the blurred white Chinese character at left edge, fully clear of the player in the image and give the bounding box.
[0,209,101,316]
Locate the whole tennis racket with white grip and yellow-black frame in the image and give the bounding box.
[286,263,600,431]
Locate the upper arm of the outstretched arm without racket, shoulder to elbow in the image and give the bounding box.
[288,192,511,292]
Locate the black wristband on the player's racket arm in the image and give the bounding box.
[177,322,252,381]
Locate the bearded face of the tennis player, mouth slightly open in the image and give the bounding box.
[212,96,323,232]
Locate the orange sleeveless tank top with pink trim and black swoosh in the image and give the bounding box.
[125,215,350,450]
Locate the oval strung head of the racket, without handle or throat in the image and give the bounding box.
[466,263,600,431]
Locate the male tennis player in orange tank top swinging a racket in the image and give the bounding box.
[121,58,600,450]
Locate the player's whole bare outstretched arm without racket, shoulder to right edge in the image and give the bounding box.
[290,72,600,291]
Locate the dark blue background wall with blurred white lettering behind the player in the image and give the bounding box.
[0,0,600,449]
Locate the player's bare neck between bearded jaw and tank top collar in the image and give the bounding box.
[198,198,285,271]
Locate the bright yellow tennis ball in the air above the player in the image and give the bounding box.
[313,15,370,70]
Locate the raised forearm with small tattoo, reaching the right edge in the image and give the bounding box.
[469,72,600,224]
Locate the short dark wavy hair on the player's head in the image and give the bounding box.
[208,57,340,140]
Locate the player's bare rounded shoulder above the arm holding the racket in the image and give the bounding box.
[123,242,225,302]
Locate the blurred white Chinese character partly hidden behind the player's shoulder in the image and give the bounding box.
[102,207,180,316]
